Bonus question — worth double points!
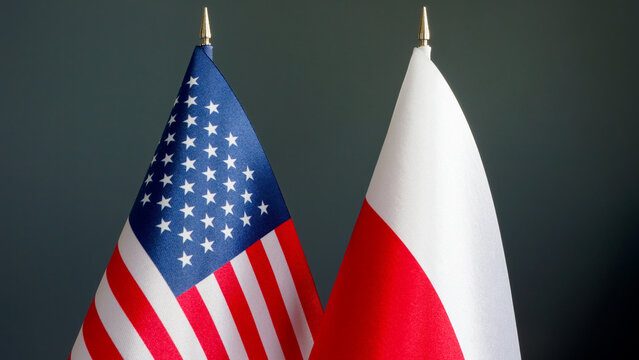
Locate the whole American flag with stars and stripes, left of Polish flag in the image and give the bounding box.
[70,46,322,359]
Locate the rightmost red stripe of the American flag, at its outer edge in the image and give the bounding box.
[275,219,323,336]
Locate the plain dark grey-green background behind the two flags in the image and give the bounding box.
[0,0,639,359]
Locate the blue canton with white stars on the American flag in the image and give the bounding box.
[129,46,290,296]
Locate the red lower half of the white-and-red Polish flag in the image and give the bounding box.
[311,202,464,360]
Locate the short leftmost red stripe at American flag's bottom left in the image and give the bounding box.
[82,300,122,360]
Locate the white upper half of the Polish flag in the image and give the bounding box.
[366,46,521,360]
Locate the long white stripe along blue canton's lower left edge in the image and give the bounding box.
[118,220,206,360]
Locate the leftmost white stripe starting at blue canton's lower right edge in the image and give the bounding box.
[196,274,248,360]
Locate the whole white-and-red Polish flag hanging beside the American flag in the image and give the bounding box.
[311,46,520,360]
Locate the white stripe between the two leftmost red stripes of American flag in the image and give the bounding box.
[95,275,153,360]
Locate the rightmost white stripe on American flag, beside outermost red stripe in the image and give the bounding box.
[262,231,313,359]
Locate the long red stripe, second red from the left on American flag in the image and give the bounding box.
[107,247,182,359]
